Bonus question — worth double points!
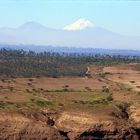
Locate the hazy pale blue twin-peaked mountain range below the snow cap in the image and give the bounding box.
[0,22,140,49]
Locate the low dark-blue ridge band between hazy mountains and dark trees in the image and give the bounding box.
[0,44,140,57]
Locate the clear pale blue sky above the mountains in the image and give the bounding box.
[0,0,140,36]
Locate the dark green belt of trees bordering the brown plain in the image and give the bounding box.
[0,49,140,77]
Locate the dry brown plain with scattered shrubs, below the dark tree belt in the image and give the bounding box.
[0,65,140,140]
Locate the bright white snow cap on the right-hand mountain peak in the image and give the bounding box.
[64,18,94,31]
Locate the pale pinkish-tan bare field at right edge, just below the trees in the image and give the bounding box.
[104,65,140,91]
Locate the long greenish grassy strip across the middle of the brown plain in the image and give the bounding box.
[0,88,115,111]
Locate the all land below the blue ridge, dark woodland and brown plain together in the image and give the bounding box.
[0,49,140,140]
